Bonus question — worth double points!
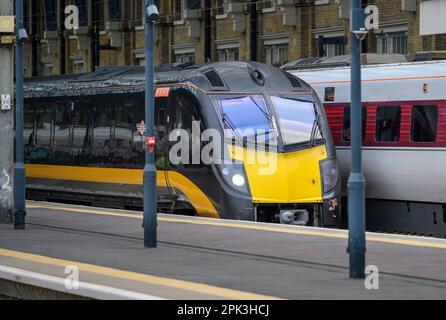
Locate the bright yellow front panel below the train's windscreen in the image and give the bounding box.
[229,146,327,203]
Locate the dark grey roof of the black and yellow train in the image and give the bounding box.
[24,61,311,98]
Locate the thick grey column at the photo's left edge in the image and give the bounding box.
[0,0,14,223]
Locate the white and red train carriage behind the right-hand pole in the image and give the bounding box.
[291,61,446,237]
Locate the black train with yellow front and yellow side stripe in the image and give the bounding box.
[24,62,340,226]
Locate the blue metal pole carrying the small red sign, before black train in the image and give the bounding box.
[143,0,157,248]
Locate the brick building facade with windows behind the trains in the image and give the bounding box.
[25,0,446,76]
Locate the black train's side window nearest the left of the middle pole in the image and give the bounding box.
[114,104,133,148]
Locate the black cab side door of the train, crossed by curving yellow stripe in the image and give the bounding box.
[165,89,209,215]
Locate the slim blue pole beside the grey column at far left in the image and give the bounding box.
[14,0,26,230]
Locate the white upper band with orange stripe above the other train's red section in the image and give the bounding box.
[293,61,446,104]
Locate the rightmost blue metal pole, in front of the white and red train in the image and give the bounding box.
[348,0,366,279]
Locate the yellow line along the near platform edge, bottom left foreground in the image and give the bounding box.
[0,249,280,300]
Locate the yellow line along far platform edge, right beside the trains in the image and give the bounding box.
[27,205,446,249]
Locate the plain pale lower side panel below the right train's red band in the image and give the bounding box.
[337,147,446,203]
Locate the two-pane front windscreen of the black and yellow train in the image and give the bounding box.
[212,94,322,149]
